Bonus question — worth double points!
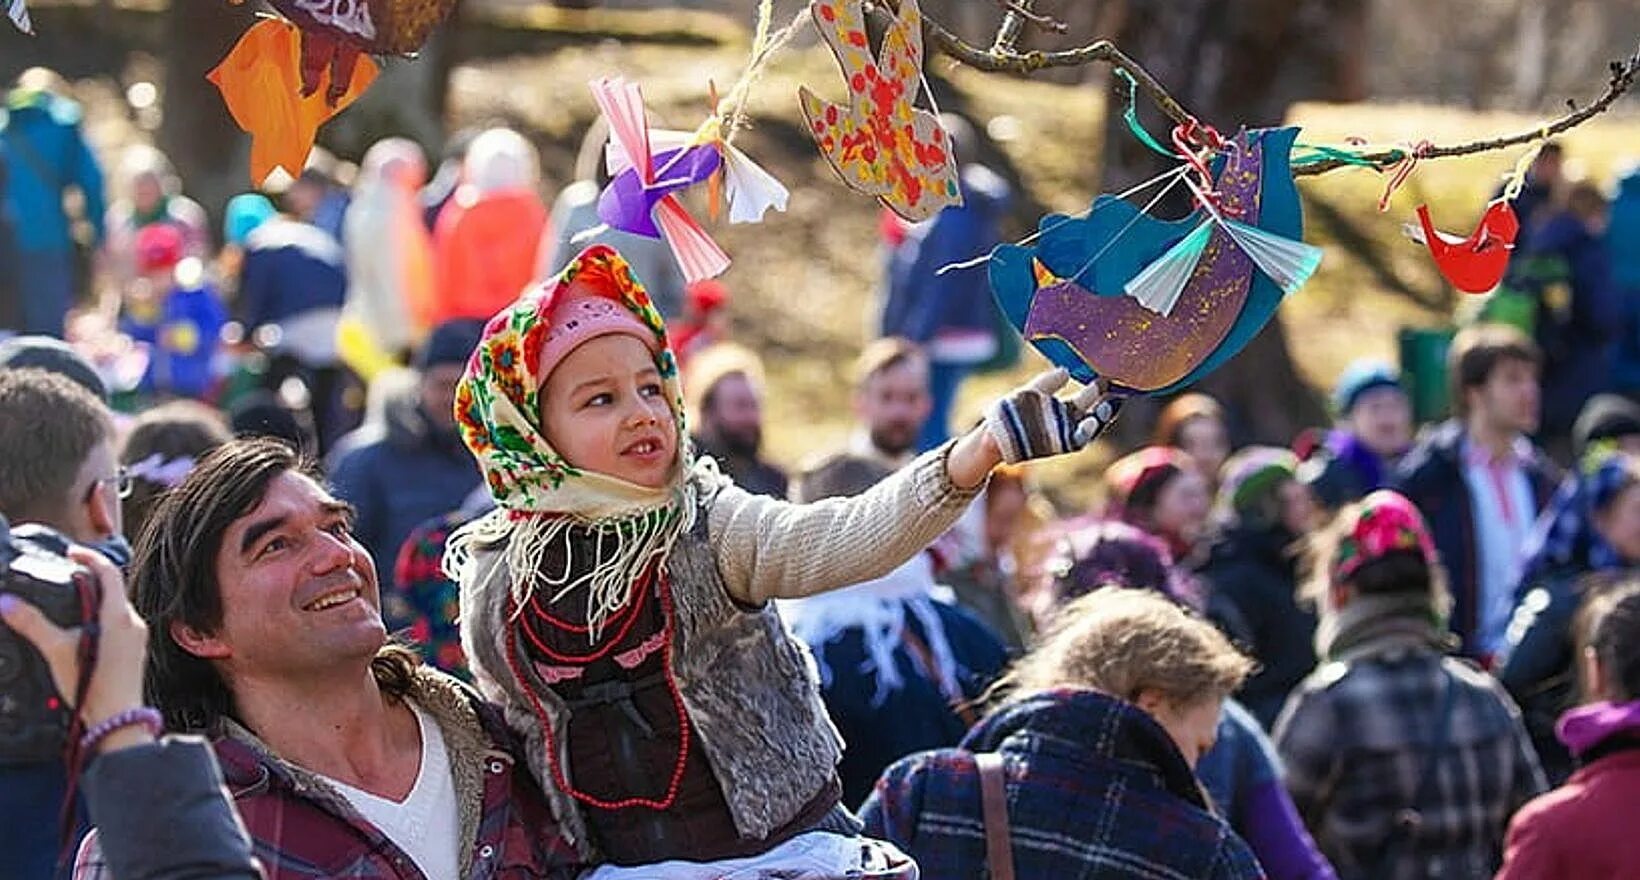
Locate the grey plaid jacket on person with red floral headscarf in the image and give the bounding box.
[1274,644,1545,880]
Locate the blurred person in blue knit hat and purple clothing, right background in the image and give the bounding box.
[1299,359,1412,511]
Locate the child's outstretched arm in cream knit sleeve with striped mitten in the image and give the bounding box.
[707,370,1118,605]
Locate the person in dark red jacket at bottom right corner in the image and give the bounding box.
[1497,578,1640,880]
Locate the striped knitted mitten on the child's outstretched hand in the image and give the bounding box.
[986,369,1122,464]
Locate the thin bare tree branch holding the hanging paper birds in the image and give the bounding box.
[911,0,1640,177]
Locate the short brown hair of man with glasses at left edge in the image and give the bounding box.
[0,367,113,526]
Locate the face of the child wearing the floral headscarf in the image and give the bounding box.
[541,334,677,488]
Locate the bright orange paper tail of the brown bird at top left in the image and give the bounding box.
[205,18,377,185]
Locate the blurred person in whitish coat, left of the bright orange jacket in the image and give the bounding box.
[341,138,433,364]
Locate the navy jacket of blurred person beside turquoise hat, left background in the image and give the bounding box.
[236,216,347,329]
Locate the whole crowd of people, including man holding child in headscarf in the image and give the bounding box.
[0,70,1640,880]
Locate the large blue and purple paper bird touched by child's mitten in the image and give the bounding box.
[991,128,1320,393]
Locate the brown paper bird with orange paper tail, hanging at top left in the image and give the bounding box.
[208,0,456,184]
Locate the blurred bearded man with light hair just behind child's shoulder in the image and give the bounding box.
[684,342,787,498]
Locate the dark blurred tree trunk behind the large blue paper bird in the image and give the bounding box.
[1104,0,1366,442]
